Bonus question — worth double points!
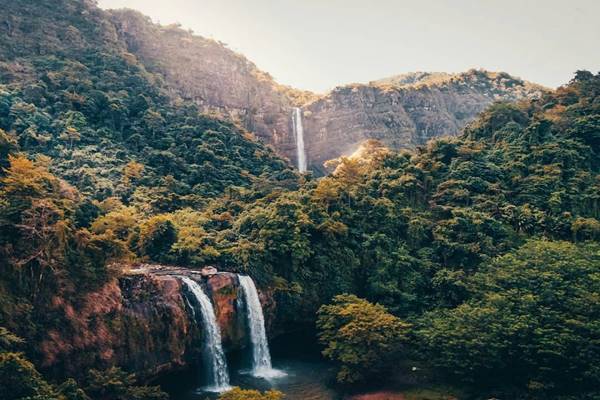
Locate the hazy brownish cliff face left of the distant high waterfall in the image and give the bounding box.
[106,10,310,154]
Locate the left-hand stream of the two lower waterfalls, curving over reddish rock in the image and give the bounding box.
[181,276,230,392]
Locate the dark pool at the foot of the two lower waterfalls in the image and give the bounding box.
[159,335,341,400]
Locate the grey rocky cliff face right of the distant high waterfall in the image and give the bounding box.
[303,70,544,167]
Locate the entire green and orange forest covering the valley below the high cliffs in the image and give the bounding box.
[0,0,600,399]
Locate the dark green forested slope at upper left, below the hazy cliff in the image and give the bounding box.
[0,1,293,203]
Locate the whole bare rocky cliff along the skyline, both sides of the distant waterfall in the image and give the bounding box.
[105,10,545,170]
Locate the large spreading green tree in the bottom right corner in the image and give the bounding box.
[416,240,600,398]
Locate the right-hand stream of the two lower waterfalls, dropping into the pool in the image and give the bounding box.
[238,275,284,378]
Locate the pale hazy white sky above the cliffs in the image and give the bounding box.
[98,0,600,92]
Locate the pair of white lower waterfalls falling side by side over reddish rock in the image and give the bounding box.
[181,275,285,392]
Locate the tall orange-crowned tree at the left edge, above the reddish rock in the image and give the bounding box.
[0,156,78,298]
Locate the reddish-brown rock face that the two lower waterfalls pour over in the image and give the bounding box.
[39,266,274,378]
